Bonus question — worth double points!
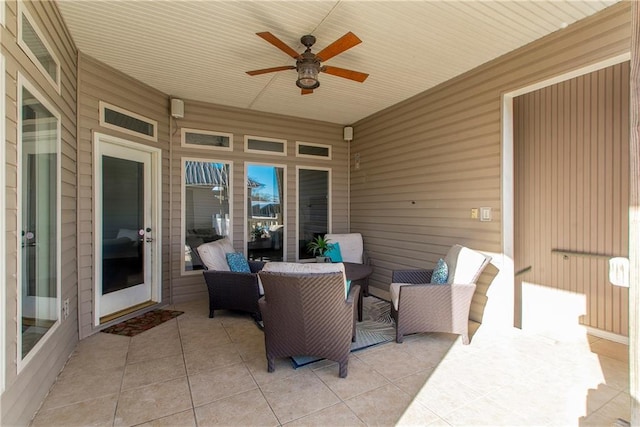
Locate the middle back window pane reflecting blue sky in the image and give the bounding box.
[247,165,284,261]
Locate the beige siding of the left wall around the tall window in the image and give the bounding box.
[0,1,78,425]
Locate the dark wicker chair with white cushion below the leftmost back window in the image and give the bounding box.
[198,238,264,320]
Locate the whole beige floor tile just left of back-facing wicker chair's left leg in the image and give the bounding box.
[189,363,258,406]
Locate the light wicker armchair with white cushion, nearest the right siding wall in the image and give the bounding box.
[389,245,491,344]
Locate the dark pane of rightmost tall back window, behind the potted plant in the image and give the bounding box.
[298,169,329,259]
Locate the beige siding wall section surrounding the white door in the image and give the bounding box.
[77,55,170,338]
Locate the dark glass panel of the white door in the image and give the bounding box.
[102,156,144,295]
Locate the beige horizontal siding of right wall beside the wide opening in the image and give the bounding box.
[350,2,630,328]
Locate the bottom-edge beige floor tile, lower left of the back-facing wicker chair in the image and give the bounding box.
[195,390,279,427]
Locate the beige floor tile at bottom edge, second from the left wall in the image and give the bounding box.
[114,377,192,426]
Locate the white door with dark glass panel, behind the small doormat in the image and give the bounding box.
[95,135,160,324]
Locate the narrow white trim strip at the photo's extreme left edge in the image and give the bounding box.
[0,54,8,393]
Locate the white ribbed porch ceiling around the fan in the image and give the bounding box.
[58,0,618,124]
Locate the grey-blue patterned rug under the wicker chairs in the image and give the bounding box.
[291,296,396,368]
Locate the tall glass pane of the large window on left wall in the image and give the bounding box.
[20,88,59,358]
